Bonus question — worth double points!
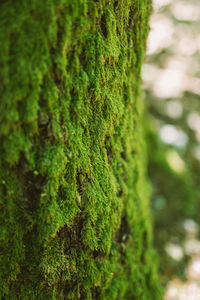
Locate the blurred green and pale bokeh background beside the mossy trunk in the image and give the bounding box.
[142,0,200,300]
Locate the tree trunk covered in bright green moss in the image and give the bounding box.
[0,0,160,300]
